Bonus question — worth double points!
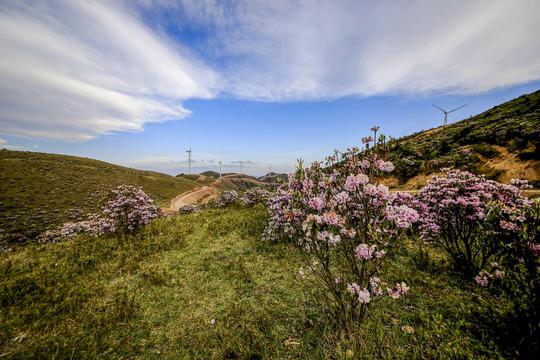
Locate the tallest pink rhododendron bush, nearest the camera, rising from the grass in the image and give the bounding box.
[264,145,418,328]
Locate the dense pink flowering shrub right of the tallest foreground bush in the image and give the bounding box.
[416,168,528,276]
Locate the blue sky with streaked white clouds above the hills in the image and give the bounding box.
[0,0,540,176]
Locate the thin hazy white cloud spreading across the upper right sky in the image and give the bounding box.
[175,0,540,101]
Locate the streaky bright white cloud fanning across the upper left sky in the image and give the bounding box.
[0,0,216,141]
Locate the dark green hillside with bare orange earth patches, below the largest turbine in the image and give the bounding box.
[390,91,540,187]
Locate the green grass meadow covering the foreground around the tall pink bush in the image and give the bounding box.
[0,207,516,359]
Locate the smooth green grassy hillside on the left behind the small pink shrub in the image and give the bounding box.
[0,150,199,246]
